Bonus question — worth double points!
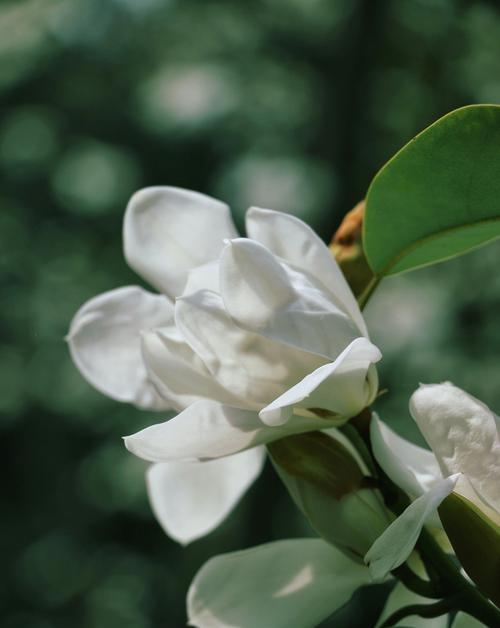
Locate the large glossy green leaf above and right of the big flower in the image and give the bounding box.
[364,105,500,276]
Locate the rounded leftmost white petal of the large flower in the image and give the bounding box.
[67,286,173,409]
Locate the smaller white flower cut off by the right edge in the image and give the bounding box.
[366,382,500,579]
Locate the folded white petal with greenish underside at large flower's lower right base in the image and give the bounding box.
[259,337,382,425]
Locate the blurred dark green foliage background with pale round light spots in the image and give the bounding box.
[0,0,500,628]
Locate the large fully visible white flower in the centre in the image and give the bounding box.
[68,187,380,542]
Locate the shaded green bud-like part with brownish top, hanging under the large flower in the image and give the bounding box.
[268,430,391,562]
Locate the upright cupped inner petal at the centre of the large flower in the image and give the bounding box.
[220,238,359,360]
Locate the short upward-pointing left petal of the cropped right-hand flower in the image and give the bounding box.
[370,414,442,497]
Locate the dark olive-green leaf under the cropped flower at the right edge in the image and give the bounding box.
[438,493,500,605]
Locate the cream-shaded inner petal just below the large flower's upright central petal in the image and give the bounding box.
[175,290,322,409]
